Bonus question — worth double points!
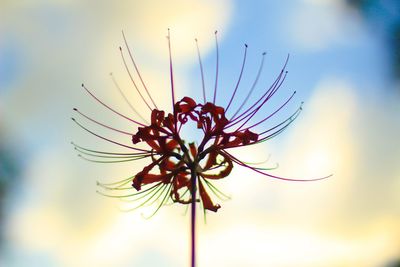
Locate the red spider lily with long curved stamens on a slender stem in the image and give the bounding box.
[73,29,326,266]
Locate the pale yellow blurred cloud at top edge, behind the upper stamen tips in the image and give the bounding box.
[90,0,233,62]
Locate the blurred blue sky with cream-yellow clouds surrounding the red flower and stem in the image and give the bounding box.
[0,0,400,267]
